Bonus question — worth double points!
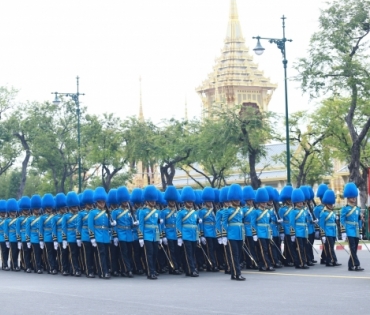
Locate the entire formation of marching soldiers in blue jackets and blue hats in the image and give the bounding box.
[0,183,363,280]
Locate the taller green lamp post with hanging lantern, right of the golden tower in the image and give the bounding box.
[253,15,292,185]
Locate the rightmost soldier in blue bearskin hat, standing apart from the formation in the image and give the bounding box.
[340,183,364,271]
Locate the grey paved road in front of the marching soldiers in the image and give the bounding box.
[0,251,370,315]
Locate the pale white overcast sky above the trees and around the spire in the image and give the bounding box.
[0,0,325,121]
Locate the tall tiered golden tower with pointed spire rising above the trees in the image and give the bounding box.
[196,0,277,118]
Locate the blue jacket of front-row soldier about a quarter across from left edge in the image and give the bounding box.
[88,209,110,244]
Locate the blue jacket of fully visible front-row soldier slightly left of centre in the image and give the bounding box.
[138,207,161,242]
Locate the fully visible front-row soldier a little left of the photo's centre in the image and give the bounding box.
[138,185,162,280]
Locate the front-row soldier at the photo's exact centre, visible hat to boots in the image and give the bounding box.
[176,186,199,277]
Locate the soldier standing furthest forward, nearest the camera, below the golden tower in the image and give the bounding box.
[222,184,245,281]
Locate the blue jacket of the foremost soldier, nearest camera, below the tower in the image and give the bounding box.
[222,207,245,241]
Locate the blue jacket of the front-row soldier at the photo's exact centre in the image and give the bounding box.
[176,208,199,242]
